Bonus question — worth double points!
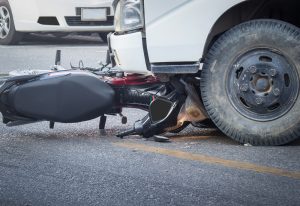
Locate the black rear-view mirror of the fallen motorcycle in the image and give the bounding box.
[149,98,173,124]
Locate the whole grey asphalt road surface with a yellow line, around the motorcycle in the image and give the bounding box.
[0,34,300,206]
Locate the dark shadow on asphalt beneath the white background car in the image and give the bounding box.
[19,34,107,46]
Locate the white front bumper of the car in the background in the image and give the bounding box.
[9,0,114,32]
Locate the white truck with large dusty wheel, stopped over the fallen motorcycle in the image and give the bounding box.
[109,0,300,145]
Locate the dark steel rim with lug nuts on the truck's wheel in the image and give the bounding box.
[226,48,299,121]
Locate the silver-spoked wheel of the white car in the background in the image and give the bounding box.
[0,0,22,45]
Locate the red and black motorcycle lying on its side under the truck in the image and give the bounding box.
[0,51,212,141]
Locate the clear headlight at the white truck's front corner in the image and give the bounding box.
[115,0,144,32]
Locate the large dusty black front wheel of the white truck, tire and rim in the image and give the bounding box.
[201,19,300,146]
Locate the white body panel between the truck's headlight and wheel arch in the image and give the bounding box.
[145,0,244,63]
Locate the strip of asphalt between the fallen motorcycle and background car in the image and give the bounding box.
[0,35,107,73]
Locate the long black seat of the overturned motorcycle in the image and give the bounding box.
[0,71,115,123]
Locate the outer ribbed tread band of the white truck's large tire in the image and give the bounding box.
[200,19,300,146]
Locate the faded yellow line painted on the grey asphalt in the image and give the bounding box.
[114,142,300,179]
